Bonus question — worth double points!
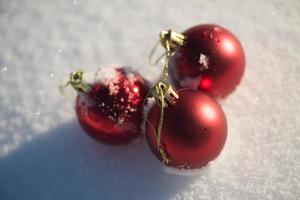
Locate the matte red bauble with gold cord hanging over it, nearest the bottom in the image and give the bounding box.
[146,89,227,168]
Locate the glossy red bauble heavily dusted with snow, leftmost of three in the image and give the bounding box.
[75,67,149,144]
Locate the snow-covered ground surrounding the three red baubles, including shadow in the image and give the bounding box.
[0,0,300,200]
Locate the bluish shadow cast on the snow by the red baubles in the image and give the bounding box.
[0,120,207,200]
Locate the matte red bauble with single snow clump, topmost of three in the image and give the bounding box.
[170,24,245,97]
